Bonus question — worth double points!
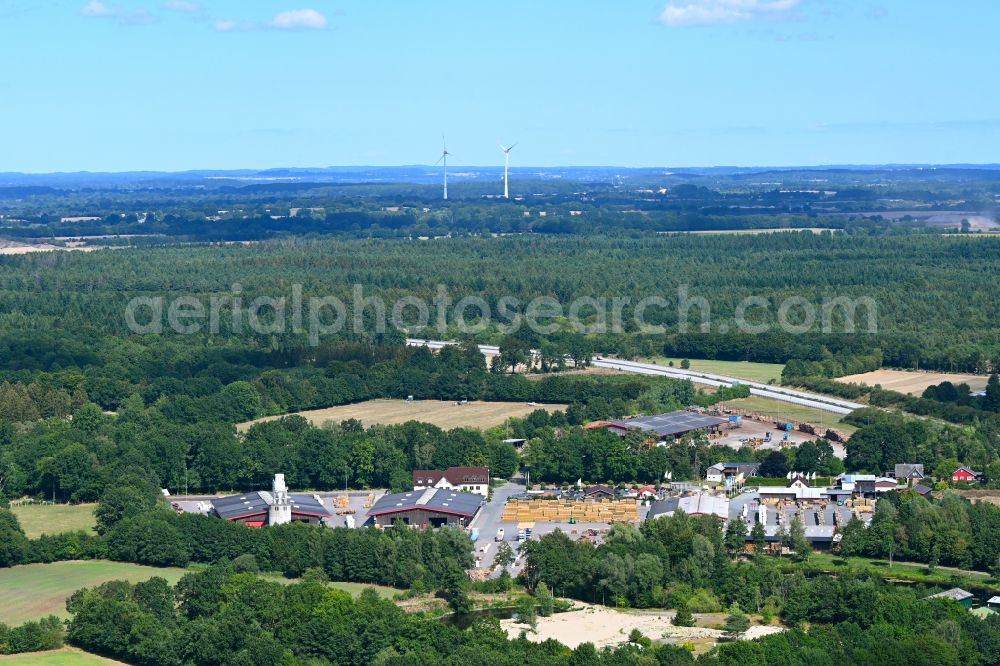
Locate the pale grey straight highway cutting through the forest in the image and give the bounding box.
[406,338,864,415]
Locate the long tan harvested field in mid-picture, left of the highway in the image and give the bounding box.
[236,400,566,431]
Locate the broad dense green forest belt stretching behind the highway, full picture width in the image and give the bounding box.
[0,232,1000,375]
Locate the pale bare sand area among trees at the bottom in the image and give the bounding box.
[500,602,784,649]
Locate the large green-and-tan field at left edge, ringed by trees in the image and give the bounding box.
[0,560,187,625]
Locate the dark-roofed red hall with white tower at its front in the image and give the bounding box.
[211,474,331,527]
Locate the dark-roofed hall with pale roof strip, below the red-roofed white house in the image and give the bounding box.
[368,488,486,528]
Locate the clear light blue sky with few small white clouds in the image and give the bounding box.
[0,0,1000,172]
